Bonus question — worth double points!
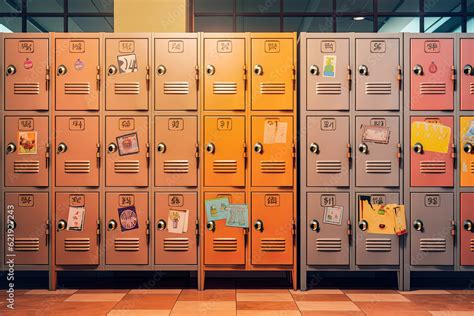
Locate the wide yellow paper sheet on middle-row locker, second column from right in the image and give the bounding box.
[411,122,451,154]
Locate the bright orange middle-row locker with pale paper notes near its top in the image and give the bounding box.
[251,116,296,187]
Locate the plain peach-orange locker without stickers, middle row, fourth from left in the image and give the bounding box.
[155,116,199,187]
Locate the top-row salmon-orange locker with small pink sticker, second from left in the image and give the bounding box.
[54,34,101,110]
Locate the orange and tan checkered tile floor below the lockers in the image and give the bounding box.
[0,289,474,316]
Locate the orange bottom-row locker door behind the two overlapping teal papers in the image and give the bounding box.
[203,192,247,265]
